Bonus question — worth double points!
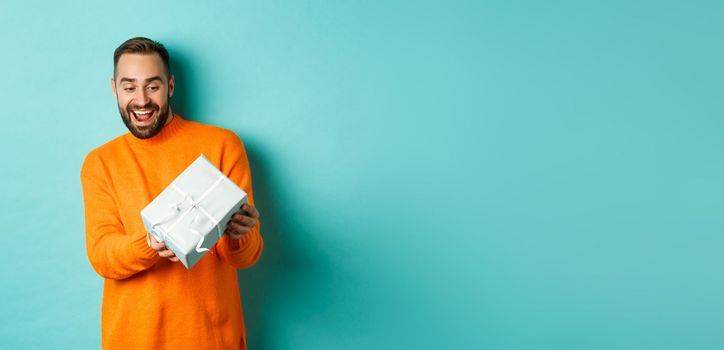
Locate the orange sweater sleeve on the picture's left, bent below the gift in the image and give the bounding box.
[80,154,160,279]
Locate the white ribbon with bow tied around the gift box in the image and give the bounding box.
[146,175,224,253]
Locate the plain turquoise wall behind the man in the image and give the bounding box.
[0,0,724,350]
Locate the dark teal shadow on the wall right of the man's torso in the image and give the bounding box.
[234,139,367,350]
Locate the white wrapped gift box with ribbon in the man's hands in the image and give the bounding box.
[141,154,247,269]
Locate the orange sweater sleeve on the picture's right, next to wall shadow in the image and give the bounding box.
[216,132,264,269]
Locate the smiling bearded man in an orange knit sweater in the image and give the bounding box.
[80,37,263,349]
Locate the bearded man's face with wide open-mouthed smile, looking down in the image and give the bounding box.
[111,53,174,139]
